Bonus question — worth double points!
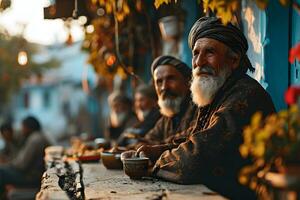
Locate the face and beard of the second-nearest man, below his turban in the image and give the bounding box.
[153,65,189,117]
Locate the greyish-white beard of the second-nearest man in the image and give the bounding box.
[158,97,183,117]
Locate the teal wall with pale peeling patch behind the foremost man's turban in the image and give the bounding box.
[242,1,289,110]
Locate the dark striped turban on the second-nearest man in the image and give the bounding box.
[151,56,192,79]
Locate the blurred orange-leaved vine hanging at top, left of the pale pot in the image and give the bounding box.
[83,0,156,81]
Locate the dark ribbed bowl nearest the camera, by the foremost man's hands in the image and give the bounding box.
[123,157,149,179]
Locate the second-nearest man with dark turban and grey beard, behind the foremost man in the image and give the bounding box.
[144,56,196,144]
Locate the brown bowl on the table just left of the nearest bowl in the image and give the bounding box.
[101,151,123,169]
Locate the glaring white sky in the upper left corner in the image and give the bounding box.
[0,0,84,45]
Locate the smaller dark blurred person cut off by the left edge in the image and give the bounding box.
[0,122,20,163]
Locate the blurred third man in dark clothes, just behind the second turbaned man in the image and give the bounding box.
[118,84,161,146]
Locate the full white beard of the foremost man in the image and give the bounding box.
[190,67,230,107]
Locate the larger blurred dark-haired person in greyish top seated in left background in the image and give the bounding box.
[0,116,49,198]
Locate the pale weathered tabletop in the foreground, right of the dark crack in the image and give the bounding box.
[82,163,224,200]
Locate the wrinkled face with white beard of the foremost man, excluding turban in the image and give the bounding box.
[191,38,238,107]
